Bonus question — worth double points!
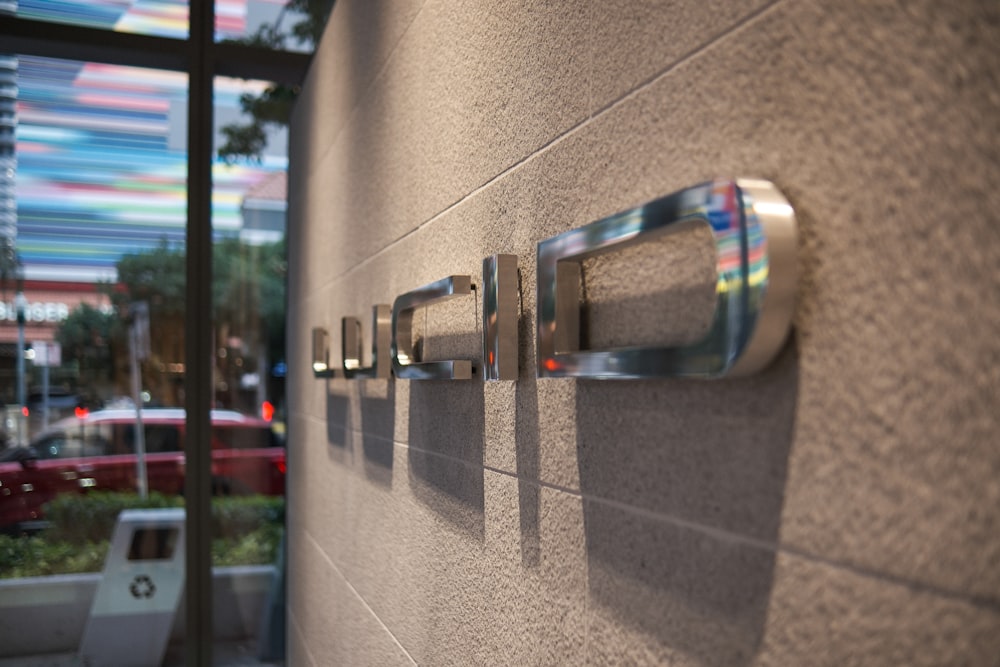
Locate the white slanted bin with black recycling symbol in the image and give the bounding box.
[80,507,184,667]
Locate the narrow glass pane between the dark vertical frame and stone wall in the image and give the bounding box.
[212,77,288,628]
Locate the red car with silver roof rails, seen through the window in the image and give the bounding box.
[0,408,285,531]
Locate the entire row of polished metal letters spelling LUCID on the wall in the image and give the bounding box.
[313,179,797,380]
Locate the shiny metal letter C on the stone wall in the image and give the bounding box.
[392,276,472,380]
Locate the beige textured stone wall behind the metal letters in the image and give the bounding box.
[289,0,1000,666]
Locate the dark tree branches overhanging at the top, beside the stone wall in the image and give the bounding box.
[219,0,334,164]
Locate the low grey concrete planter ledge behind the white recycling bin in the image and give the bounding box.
[0,565,275,657]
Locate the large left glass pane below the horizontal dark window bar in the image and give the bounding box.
[0,56,188,656]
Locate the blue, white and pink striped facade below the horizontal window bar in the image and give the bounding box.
[16,51,287,282]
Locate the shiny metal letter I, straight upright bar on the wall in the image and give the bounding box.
[483,255,518,380]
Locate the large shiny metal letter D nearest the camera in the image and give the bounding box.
[537,179,797,379]
